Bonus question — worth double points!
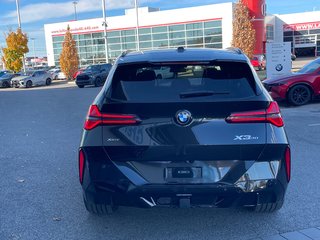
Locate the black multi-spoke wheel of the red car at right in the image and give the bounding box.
[288,84,311,106]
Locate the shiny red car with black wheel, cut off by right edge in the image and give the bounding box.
[263,58,320,106]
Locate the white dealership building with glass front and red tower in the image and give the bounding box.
[44,0,320,66]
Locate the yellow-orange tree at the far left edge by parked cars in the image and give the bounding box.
[2,28,29,72]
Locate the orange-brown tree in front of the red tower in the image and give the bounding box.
[231,0,256,58]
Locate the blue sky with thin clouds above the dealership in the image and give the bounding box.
[0,0,320,56]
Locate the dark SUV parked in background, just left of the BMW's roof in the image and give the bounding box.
[76,63,112,88]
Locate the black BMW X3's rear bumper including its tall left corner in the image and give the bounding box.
[82,148,288,208]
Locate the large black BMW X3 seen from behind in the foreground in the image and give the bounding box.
[79,48,291,214]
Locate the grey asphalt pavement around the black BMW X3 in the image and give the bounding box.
[0,86,320,240]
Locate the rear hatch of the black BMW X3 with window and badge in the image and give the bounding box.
[100,61,276,183]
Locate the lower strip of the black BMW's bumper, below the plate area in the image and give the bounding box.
[84,180,285,208]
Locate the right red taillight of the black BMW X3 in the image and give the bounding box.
[226,102,284,127]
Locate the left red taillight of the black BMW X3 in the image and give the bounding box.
[84,105,140,130]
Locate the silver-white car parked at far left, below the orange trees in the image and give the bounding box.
[11,70,52,88]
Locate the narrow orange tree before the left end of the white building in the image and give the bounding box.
[59,26,79,80]
